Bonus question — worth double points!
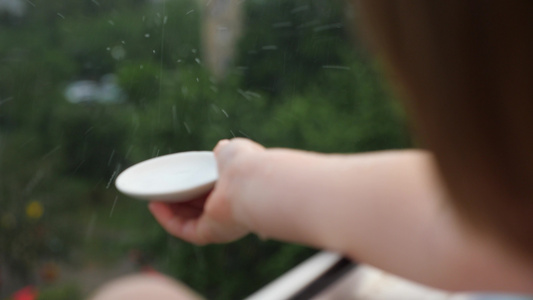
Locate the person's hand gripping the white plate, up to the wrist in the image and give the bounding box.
[149,139,264,245]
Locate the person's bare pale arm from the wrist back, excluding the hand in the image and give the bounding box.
[235,150,532,290]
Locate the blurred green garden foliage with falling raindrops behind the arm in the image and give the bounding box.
[0,0,411,299]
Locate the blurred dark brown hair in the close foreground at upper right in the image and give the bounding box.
[355,0,533,258]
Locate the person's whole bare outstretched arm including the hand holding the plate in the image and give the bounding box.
[149,139,533,293]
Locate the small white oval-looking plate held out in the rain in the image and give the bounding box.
[115,151,218,202]
